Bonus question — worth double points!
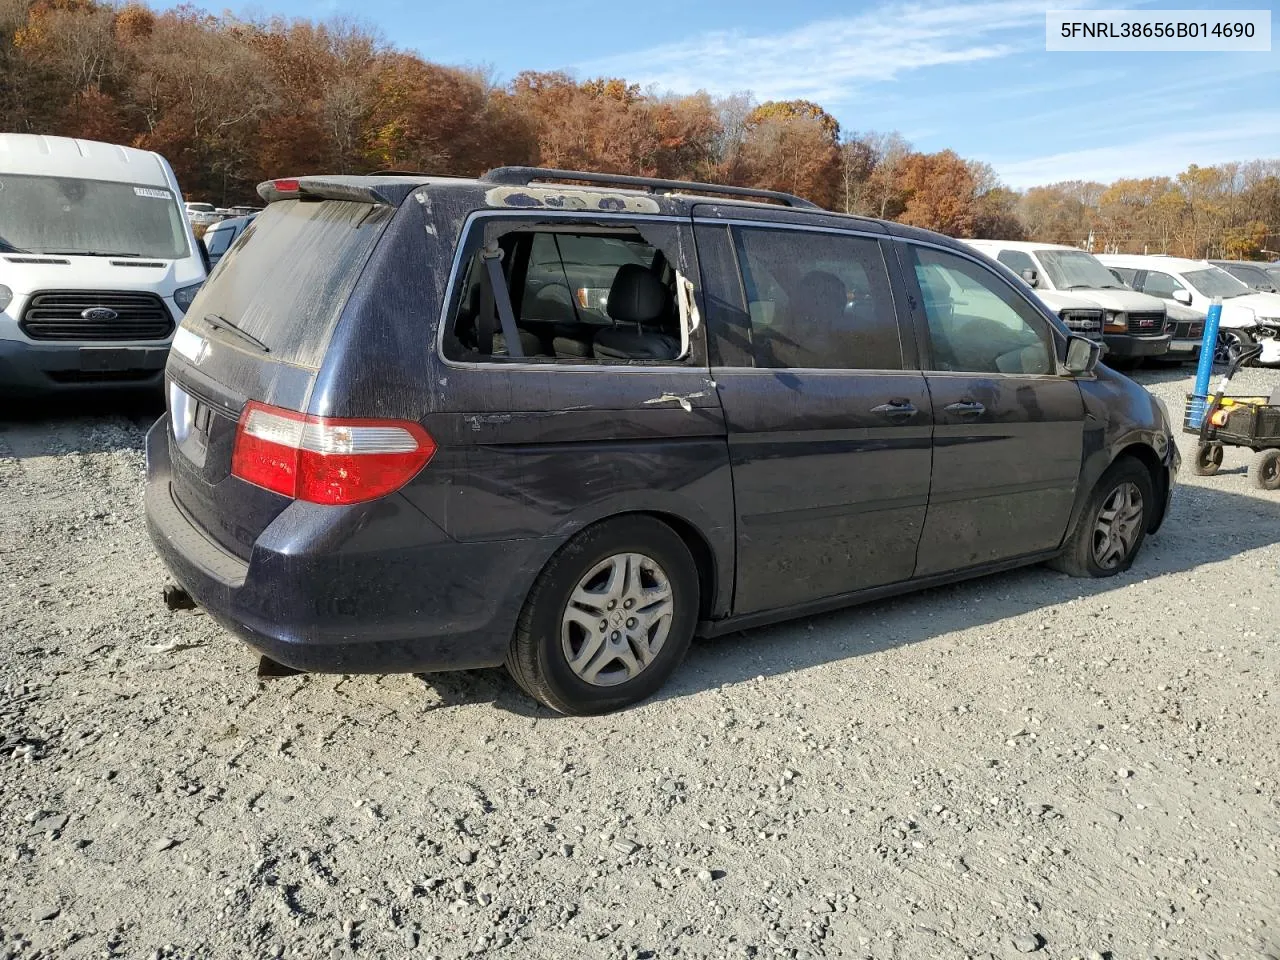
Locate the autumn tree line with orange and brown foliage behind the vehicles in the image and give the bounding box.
[0,0,1280,259]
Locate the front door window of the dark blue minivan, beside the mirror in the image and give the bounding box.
[908,244,1055,374]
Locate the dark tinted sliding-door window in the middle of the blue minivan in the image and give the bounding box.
[733,227,902,370]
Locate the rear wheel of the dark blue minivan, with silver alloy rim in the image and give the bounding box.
[507,516,699,716]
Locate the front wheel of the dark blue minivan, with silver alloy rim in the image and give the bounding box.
[1050,457,1156,577]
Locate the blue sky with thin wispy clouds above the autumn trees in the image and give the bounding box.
[194,0,1280,187]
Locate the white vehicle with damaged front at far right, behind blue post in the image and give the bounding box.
[1098,253,1280,365]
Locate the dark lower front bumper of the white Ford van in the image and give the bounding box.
[0,339,169,394]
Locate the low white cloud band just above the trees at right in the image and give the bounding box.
[983,110,1280,188]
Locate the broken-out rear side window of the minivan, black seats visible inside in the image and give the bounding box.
[444,218,696,364]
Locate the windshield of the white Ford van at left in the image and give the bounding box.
[0,173,189,260]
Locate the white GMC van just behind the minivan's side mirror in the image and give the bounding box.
[965,239,1172,362]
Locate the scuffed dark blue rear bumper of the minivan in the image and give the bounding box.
[146,416,556,673]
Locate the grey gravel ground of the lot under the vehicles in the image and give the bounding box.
[0,371,1280,960]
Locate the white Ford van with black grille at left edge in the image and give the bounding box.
[0,133,205,393]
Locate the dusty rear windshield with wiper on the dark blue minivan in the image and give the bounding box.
[184,200,394,369]
